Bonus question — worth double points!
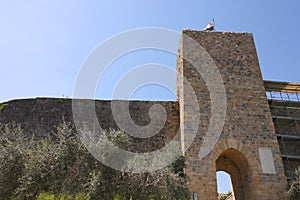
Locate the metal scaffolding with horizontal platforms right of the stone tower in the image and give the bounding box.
[264,81,300,179]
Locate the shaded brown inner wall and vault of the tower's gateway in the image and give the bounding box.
[216,148,253,200]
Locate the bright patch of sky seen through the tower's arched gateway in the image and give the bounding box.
[217,171,232,194]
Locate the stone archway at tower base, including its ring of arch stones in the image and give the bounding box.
[210,139,261,200]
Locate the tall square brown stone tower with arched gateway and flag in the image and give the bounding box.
[177,30,287,200]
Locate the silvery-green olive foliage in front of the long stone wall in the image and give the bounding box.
[0,123,190,200]
